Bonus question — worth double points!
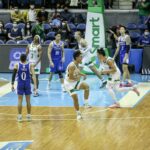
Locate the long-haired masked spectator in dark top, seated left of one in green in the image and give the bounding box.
[23,22,32,43]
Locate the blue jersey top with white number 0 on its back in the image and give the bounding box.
[17,63,31,83]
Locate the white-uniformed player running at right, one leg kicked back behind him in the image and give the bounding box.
[97,48,140,107]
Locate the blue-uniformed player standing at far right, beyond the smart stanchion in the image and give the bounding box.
[113,26,131,84]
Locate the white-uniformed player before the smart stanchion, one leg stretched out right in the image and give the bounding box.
[75,31,106,88]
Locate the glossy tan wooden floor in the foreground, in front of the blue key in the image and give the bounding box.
[0,94,150,150]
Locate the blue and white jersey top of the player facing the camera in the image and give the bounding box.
[51,41,63,61]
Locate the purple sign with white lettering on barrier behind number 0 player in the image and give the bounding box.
[9,48,26,70]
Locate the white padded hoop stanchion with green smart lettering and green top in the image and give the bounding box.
[85,0,105,54]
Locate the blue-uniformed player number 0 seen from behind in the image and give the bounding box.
[12,54,37,122]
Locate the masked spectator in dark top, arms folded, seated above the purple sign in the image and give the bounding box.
[8,22,22,41]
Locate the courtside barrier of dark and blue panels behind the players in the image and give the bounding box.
[0,45,144,73]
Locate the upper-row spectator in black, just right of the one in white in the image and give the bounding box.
[37,6,48,22]
